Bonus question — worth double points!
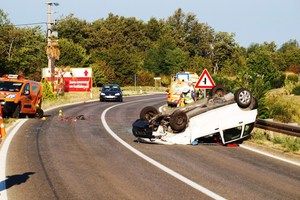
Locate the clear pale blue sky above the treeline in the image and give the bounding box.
[0,0,300,47]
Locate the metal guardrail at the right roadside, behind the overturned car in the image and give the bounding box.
[255,119,300,137]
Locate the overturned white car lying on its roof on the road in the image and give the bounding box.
[132,88,257,144]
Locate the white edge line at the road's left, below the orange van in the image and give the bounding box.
[0,119,27,200]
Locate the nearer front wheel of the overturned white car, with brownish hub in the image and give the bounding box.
[170,110,188,132]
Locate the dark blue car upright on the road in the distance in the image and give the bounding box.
[99,84,123,102]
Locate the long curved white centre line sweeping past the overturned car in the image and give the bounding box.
[101,98,225,200]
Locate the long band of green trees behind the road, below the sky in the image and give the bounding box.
[0,9,300,90]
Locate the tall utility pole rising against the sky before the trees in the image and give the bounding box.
[46,0,59,86]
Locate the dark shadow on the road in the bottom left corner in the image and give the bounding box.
[0,172,35,192]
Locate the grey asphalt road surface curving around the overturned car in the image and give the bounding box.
[0,95,300,200]
